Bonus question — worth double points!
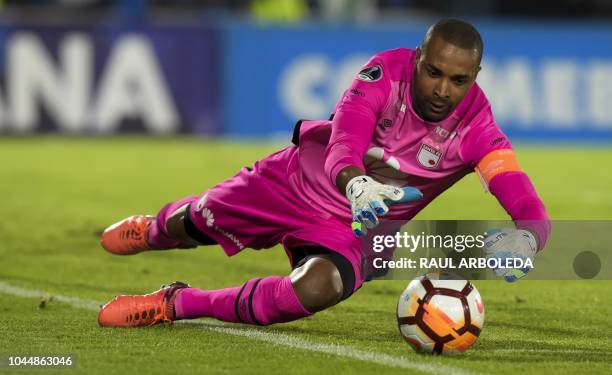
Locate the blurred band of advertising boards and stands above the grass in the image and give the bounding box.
[0,0,612,142]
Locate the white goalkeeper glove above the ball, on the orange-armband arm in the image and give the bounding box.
[484,228,537,283]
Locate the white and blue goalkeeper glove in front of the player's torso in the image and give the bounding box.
[346,176,423,237]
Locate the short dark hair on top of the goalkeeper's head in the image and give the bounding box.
[421,19,484,65]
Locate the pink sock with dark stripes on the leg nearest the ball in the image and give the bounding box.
[174,276,312,325]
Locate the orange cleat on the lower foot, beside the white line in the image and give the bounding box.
[98,281,189,327]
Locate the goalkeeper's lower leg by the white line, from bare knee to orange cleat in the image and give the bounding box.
[98,255,343,327]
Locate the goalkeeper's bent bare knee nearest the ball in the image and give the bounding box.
[291,256,344,312]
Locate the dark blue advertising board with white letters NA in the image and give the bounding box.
[0,24,220,135]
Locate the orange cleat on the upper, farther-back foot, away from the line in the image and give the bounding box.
[100,215,155,255]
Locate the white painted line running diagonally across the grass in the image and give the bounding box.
[0,281,474,375]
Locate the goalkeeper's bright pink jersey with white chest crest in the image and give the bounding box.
[288,48,511,222]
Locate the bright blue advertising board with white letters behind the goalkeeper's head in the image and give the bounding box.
[222,22,612,141]
